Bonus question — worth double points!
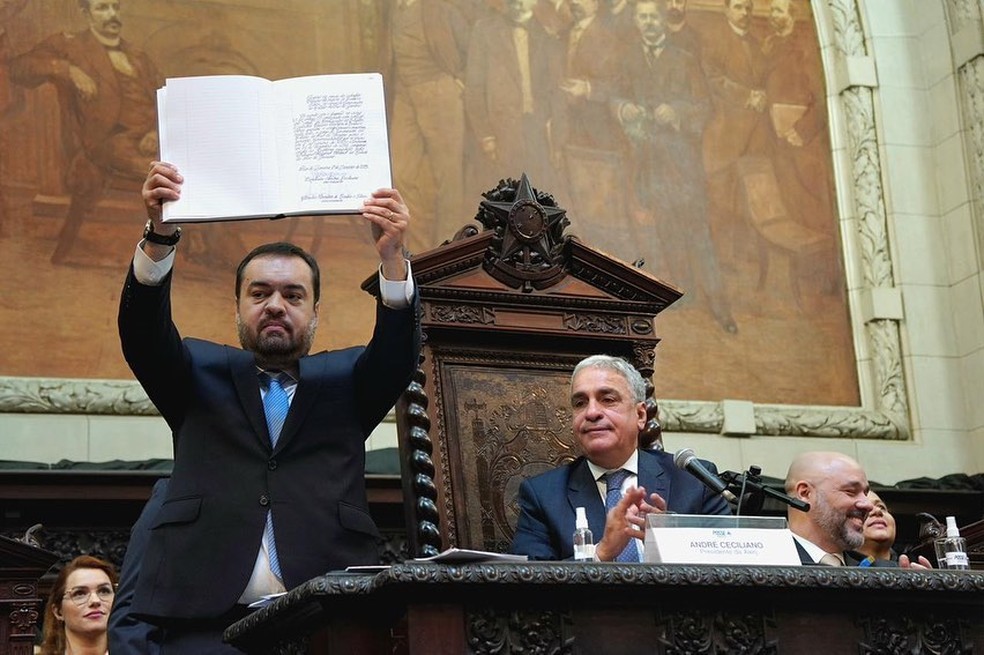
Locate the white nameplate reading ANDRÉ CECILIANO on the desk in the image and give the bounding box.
[644,527,800,566]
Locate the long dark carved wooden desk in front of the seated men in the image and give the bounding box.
[226,562,984,655]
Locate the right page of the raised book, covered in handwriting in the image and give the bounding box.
[270,73,393,214]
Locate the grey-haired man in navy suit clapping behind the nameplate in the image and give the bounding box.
[510,355,730,561]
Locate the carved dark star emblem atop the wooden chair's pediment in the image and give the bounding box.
[482,173,566,263]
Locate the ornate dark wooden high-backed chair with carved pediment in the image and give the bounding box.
[364,175,682,556]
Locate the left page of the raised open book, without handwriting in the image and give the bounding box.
[158,75,276,221]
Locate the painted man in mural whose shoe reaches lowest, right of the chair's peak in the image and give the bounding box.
[613,0,738,333]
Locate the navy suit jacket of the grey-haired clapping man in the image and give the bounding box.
[509,450,731,560]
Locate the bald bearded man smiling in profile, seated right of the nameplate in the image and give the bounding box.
[786,452,932,568]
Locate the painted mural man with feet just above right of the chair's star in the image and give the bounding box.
[553,0,624,255]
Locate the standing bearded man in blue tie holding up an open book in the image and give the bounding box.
[119,162,420,654]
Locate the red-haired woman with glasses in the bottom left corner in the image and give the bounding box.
[41,555,116,655]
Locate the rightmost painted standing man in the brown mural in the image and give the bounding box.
[762,0,840,292]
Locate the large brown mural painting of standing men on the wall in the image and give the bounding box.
[0,0,859,406]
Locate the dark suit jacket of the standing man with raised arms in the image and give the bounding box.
[119,266,420,622]
